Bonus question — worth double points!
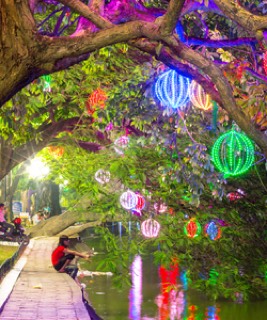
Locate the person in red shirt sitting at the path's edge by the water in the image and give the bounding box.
[51,235,91,289]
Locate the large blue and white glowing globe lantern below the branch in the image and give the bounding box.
[155,70,190,109]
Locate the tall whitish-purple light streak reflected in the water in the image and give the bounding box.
[129,255,142,320]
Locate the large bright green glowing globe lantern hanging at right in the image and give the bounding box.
[211,130,254,177]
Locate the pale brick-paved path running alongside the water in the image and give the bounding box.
[0,238,90,320]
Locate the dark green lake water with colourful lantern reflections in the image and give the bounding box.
[82,229,267,320]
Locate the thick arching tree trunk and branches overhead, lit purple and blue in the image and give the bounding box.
[0,0,267,155]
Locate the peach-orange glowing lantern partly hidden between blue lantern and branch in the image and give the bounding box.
[189,81,212,111]
